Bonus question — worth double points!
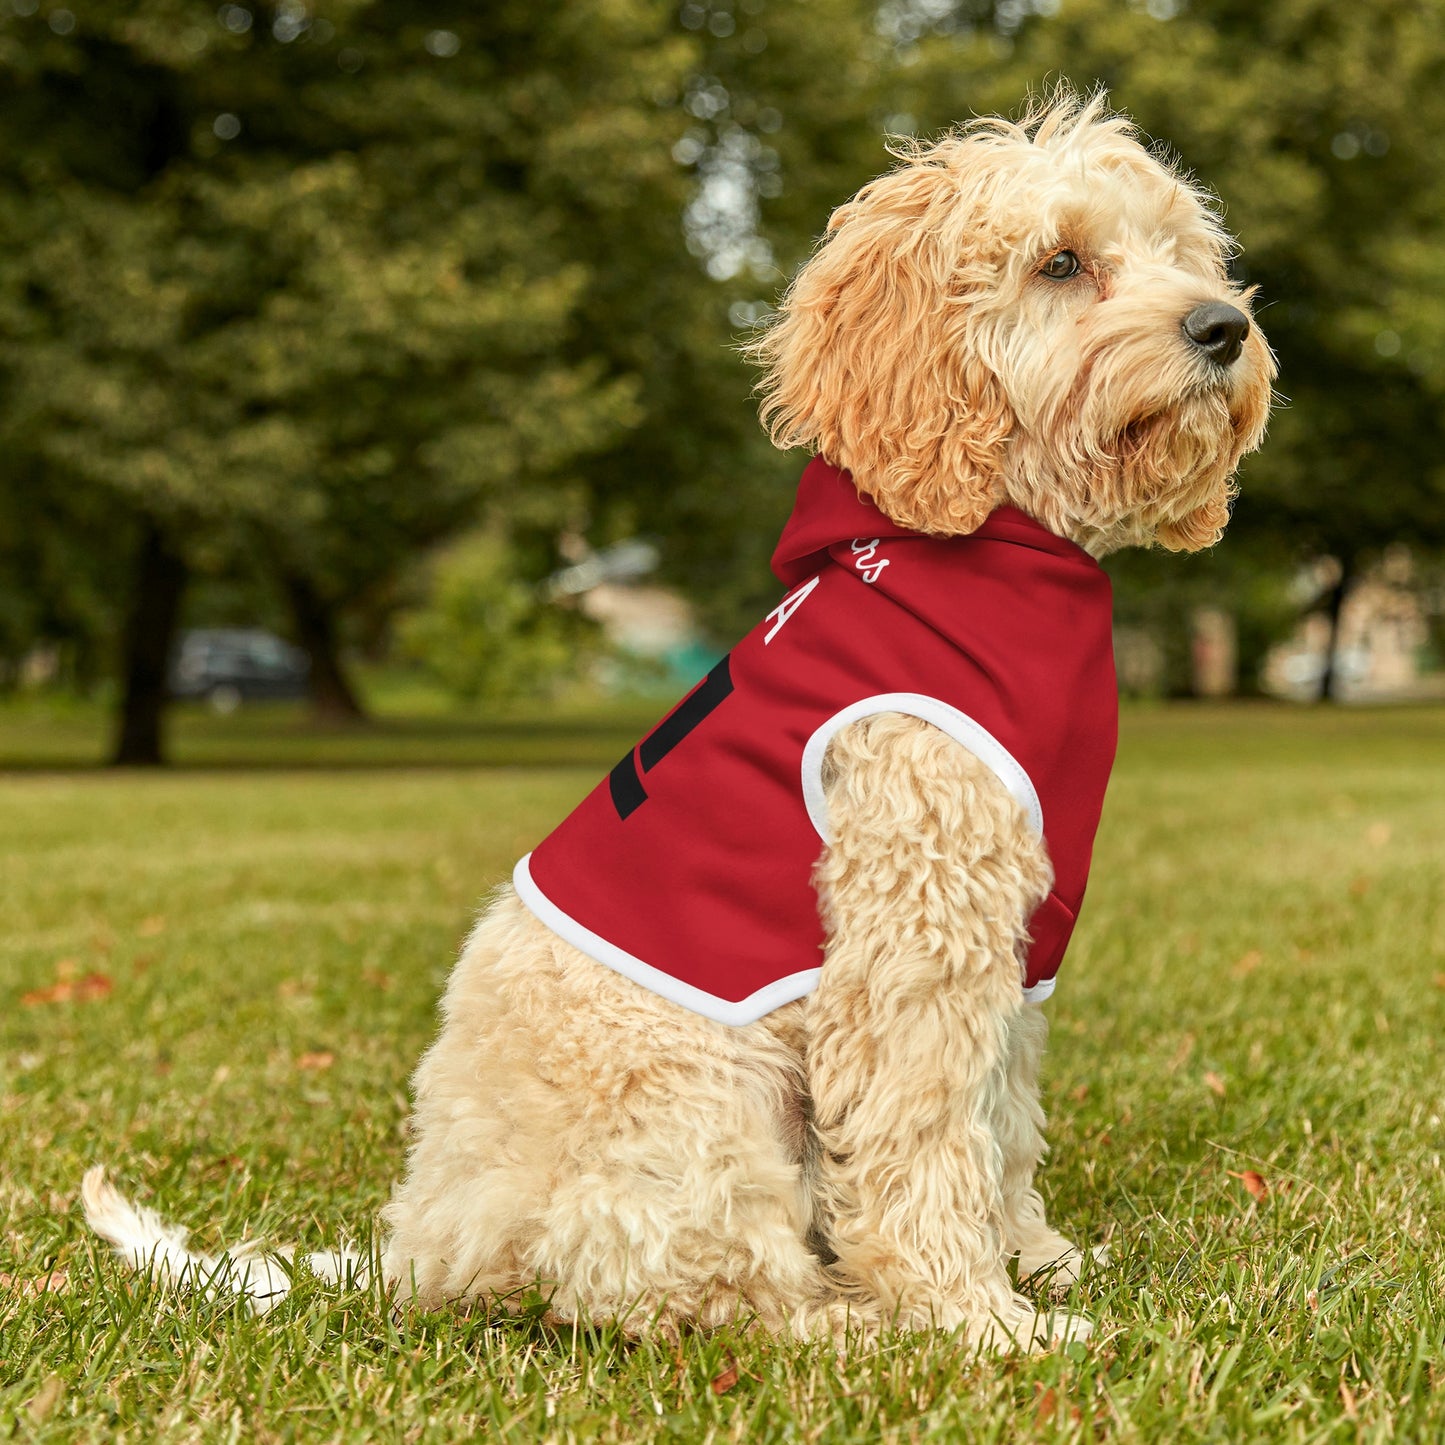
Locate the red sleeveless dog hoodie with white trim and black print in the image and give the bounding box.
[519,460,1117,1022]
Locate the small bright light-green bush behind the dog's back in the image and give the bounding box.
[397,532,595,702]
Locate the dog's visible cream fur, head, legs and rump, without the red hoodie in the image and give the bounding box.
[87,94,1273,1345]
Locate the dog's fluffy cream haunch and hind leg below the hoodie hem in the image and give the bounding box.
[384,889,825,1335]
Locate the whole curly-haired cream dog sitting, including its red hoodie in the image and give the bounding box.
[87,94,1273,1344]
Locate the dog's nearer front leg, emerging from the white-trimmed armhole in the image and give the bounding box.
[808,714,1088,1345]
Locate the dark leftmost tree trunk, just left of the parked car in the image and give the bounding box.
[111,522,186,767]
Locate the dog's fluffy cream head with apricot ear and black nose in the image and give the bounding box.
[751,91,1274,553]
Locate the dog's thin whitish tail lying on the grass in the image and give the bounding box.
[81,1165,370,1315]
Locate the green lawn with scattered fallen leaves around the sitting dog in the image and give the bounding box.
[0,707,1445,1442]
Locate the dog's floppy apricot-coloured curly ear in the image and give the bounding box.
[749,139,1013,533]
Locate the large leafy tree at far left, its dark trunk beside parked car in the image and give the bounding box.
[0,0,689,763]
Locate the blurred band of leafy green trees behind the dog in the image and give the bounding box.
[0,0,1445,762]
